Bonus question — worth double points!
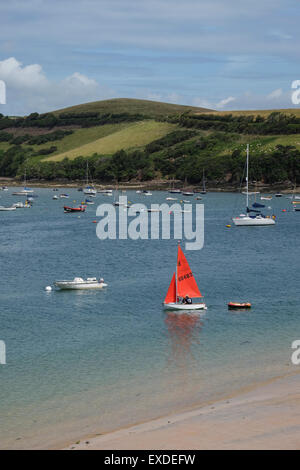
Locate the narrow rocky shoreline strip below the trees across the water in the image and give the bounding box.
[0,177,300,194]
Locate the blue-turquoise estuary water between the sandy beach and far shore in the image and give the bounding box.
[0,189,300,448]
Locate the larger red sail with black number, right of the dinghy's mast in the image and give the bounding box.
[177,245,202,298]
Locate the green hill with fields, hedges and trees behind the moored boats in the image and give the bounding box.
[0,99,300,186]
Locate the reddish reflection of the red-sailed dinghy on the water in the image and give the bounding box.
[165,312,203,368]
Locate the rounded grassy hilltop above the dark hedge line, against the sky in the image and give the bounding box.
[53,98,209,117]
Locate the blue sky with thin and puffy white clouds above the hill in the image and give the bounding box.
[0,0,300,115]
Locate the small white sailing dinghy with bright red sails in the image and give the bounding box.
[163,245,207,310]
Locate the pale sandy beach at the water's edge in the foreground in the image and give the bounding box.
[67,373,300,450]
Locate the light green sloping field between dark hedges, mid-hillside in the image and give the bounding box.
[43,121,177,162]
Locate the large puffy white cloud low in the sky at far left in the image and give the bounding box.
[0,57,113,115]
